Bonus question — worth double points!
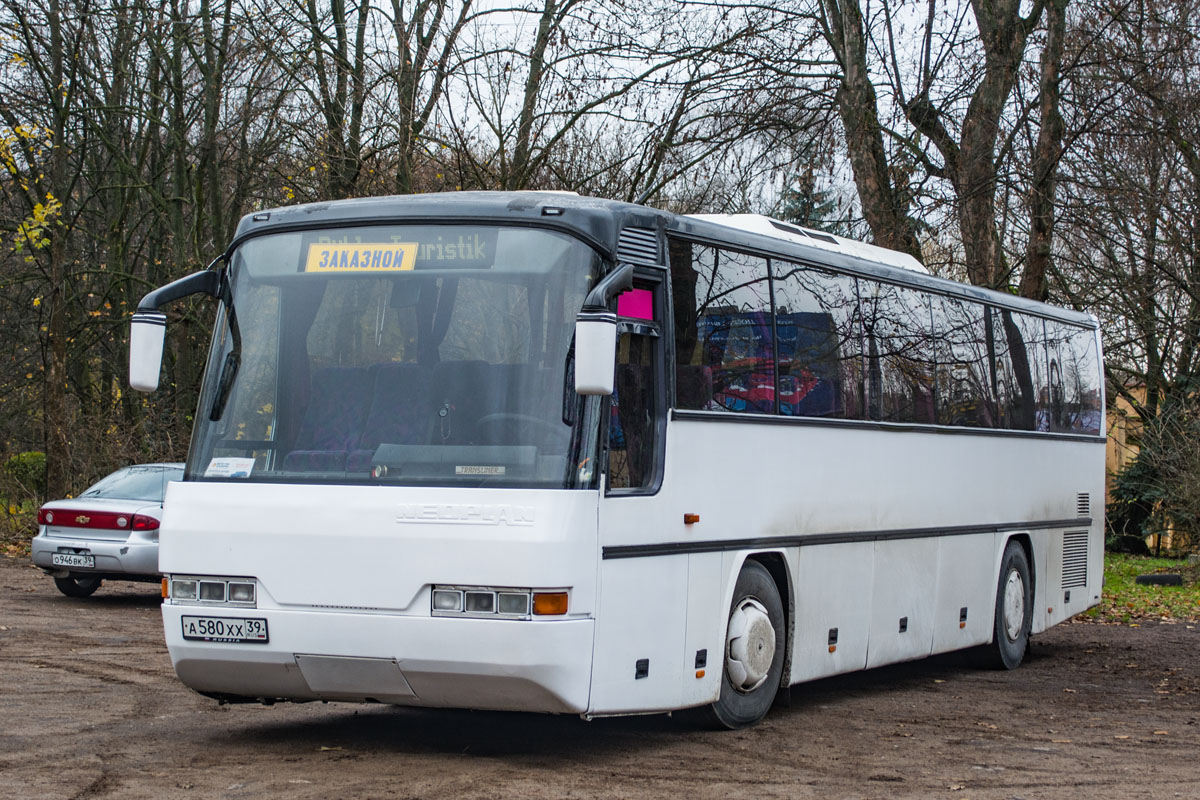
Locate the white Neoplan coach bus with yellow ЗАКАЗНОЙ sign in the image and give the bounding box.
[131,193,1104,727]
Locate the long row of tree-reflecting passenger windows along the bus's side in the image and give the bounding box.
[671,240,1103,435]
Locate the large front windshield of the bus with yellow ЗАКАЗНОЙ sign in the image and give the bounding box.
[186,225,601,488]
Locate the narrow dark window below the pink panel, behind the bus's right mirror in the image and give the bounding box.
[608,333,659,489]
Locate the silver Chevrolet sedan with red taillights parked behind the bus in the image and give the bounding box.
[32,464,184,597]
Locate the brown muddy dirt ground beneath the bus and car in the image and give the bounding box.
[0,558,1200,800]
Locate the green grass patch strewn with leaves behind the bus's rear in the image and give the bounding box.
[1084,553,1200,625]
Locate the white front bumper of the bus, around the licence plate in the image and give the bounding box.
[162,602,593,714]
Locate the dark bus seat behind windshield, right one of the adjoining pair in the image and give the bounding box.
[346,363,437,473]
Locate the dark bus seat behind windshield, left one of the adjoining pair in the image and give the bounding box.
[283,367,374,471]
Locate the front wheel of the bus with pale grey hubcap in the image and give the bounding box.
[698,561,787,730]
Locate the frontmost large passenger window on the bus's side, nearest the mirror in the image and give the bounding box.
[671,241,775,414]
